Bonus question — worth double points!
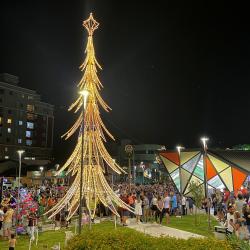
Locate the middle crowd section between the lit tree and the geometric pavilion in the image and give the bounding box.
[107,183,194,226]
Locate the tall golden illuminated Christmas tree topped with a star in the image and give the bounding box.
[48,13,132,219]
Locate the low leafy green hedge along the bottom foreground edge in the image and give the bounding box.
[66,224,233,250]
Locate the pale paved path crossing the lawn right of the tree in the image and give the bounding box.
[128,219,205,239]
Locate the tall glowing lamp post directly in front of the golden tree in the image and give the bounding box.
[78,89,91,234]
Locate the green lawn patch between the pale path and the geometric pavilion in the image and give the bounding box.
[162,214,219,237]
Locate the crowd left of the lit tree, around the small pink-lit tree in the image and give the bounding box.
[0,182,67,243]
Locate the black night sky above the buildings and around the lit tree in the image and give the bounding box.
[0,0,250,162]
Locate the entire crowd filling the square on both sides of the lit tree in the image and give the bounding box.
[0,182,250,245]
